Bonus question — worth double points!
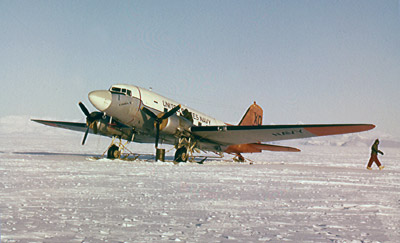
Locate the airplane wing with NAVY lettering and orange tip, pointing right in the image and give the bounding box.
[191,124,375,145]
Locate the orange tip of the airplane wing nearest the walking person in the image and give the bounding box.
[305,124,375,136]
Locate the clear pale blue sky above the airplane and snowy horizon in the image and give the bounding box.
[0,0,400,137]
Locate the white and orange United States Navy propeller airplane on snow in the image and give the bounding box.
[32,84,375,162]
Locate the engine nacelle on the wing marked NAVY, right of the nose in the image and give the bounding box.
[160,115,193,135]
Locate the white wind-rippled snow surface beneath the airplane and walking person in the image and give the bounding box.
[0,118,400,242]
